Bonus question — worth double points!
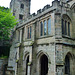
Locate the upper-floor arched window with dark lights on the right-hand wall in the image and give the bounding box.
[61,14,73,36]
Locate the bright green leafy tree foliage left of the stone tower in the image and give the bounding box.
[0,7,17,40]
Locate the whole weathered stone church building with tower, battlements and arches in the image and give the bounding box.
[7,0,75,75]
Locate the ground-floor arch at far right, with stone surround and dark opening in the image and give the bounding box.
[64,52,75,75]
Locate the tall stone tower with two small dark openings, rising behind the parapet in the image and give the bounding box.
[10,0,31,21]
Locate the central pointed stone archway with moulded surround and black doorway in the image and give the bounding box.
[37,50,51,75]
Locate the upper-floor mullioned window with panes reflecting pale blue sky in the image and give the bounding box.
[40,18,51,36]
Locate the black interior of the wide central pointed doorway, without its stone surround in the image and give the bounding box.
[40,54,48,75]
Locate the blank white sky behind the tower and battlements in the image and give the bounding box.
[0,0,53,13]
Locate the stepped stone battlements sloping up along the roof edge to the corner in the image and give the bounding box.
[18,0,70,26]
